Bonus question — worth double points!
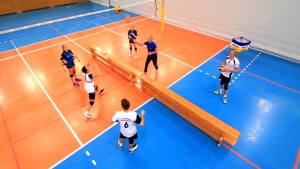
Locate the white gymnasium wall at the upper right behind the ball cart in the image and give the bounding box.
[165,0,300,61]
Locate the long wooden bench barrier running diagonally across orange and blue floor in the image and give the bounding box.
[90,46,240,146]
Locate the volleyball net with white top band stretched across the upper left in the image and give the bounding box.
[0,1,155,52]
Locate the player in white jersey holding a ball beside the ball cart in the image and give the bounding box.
[214,50,240,104]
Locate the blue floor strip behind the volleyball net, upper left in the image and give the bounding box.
[0,2,138,52]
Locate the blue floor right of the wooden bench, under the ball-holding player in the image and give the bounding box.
[171,49,300,169]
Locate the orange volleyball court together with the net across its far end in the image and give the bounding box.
[0,2,232,168]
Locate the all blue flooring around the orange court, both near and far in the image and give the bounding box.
[0,3,300,169]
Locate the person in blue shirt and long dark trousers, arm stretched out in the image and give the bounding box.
[134,36,158,74]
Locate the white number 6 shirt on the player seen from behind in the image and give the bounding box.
[112,111,140,138]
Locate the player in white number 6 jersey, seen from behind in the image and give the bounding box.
[112,99,145,153]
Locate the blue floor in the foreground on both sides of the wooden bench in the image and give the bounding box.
[55,46,300,169]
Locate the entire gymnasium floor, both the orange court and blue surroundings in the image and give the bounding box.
[0,2,300,169]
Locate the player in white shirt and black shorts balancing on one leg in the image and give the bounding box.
[82,66,104,119]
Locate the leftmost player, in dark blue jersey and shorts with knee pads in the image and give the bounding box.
[60,45,81,86]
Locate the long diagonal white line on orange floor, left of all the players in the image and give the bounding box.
[11,40,83,146]
